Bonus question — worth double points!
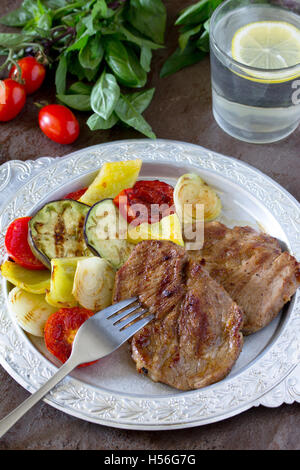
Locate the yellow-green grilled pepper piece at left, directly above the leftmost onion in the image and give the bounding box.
[1,261,50,294]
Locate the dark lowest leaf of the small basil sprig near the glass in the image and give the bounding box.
[160,43,206,77]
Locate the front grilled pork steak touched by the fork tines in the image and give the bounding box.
[114,240,243,390]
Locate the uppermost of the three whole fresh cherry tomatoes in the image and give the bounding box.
[9,57,46,95]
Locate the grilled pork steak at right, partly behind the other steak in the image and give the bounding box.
[189,222,300,335]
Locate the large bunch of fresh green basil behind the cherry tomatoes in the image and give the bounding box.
[0,0,166,138]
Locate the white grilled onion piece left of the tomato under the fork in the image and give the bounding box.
[8,287,57,336]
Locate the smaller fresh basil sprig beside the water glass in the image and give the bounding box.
[160,0,223,77]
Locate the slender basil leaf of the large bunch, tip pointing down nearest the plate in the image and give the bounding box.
[115,96,156,139]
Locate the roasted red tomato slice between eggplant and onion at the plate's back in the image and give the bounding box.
[114,180,175,225]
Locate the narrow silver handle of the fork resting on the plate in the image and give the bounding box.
[0,357,78,438]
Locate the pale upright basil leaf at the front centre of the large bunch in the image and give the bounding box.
[91,71,120,119]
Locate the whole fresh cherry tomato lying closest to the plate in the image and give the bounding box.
[39,104,80,144]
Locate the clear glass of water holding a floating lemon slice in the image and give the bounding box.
[210,0,300,143]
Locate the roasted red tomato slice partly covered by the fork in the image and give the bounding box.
[44,307,97,367]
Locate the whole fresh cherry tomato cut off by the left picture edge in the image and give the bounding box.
[0,78,26,122]
